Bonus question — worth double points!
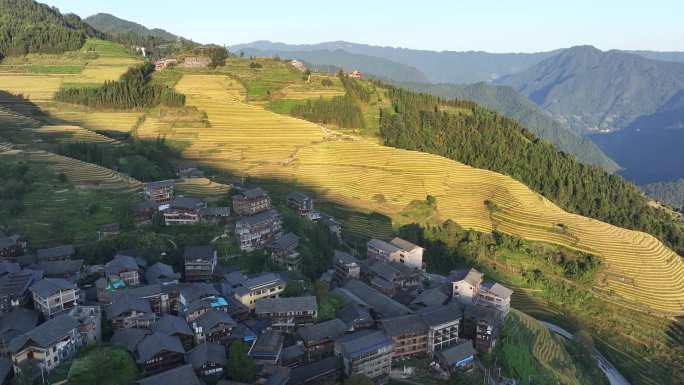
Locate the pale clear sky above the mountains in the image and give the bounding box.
[45,0,684,52]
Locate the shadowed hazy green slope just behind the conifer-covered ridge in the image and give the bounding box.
[401,83,618,172]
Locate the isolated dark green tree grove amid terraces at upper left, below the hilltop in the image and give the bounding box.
[55,63,185,109]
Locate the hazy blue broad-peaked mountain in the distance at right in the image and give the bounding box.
[495,46,684,132]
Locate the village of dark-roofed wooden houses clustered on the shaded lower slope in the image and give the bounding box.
[0,181,512,385]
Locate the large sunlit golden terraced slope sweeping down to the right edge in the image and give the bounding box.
[164,75,684,314]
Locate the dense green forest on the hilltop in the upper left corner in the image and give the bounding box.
[0,0,104,59]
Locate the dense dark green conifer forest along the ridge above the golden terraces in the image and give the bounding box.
[380,86,684,254]
